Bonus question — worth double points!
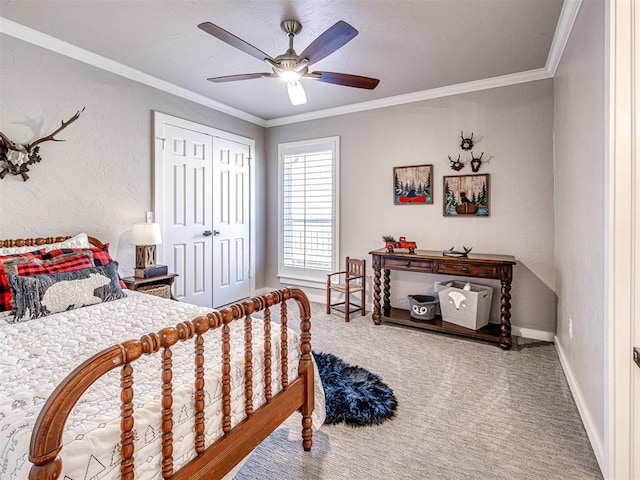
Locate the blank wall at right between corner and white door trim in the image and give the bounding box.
[554,0,607,466]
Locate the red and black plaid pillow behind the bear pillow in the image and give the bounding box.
[0,253,94,311]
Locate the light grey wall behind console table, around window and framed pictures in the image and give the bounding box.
[266,80,556,332]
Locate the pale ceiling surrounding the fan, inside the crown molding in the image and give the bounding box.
[0,0,562,124]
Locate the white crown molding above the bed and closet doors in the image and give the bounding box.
[0,17,266,127]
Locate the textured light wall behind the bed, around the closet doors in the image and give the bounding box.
[0,35,265,285]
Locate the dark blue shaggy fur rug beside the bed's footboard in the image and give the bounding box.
[312,352,398,427]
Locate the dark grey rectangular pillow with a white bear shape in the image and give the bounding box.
[9,262,127,323]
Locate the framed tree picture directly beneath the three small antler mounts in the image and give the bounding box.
[442,174,489,217]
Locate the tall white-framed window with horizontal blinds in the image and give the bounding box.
[278,137,339,287]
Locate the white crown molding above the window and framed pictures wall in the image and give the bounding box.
[266,68,553,128]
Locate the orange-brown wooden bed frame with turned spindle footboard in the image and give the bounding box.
[0,237,314,480]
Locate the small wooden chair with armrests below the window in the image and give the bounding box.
[327,257,366,322]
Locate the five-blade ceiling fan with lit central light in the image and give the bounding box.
[198,20,380,105]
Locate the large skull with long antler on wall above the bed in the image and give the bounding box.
[0,107,84,182]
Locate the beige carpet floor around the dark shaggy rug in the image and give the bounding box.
[235,304,602,480]
